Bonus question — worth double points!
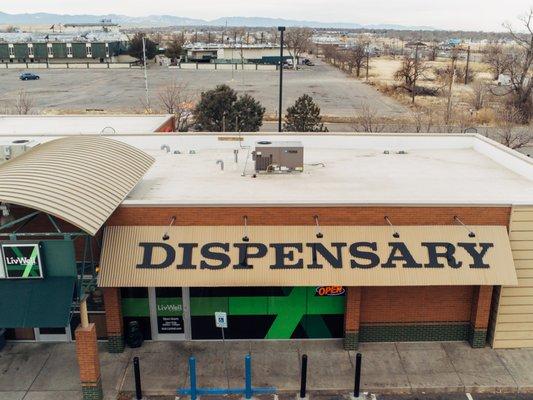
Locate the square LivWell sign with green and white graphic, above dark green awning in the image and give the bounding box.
[2,243,43,279]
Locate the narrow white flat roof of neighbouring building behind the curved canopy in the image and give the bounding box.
[0,115,172,136]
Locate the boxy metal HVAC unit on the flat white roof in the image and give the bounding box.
[253,141,304,172]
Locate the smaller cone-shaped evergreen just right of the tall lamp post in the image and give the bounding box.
[283,94,328,132]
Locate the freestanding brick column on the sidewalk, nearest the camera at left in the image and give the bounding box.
[75,324,104,400]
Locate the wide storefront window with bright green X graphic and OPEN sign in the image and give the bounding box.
[190,287,344,339]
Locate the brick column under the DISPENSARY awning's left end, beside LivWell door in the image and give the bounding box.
[104,288,124,353]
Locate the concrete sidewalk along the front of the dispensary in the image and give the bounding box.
[0,340,533,400]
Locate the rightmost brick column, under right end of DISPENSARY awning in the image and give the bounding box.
[469,286,493,348]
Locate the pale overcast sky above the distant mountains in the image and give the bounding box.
[0,0,533,31]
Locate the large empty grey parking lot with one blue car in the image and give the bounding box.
[0,62,405,117]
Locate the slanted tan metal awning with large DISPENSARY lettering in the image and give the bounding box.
[99,226,517,287]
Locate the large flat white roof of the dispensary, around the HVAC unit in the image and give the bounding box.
[2,133,533,206]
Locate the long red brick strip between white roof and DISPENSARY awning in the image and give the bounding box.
[108,206,511,226]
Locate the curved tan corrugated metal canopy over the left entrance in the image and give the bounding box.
[0,136,154,235]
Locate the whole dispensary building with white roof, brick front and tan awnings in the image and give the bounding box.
[0,133,533,360]
